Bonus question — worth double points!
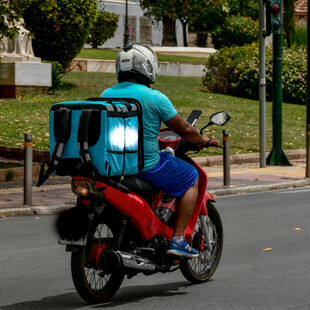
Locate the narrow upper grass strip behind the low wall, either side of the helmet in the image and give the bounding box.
[76,49,206,65]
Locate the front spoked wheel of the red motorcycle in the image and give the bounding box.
[180,202,223,283]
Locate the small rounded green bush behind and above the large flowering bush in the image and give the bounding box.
[212,15,259,49]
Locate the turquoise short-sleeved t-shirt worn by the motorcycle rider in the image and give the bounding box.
[100,82,177,171]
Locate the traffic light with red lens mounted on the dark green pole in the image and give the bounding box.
[266,0,282,36]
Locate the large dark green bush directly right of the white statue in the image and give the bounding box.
[23,0,97,69]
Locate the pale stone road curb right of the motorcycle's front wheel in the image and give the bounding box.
[209,179,310,196]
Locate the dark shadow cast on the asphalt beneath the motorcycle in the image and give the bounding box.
[0,281,192,310]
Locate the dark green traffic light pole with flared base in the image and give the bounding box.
[267,0,291,166]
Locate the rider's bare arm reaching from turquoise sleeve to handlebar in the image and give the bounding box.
[165,113,210,148]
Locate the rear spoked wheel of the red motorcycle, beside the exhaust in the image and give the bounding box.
[71,221,124,304]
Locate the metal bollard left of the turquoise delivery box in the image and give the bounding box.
[24,134,33,206]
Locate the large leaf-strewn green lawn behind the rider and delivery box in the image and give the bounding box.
[0,72,306,155]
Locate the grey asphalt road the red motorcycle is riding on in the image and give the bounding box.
[0,189,310,310]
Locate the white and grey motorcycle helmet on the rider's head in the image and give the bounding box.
[116,44,158,85]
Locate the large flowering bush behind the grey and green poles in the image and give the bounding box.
[204,44,307,104]
